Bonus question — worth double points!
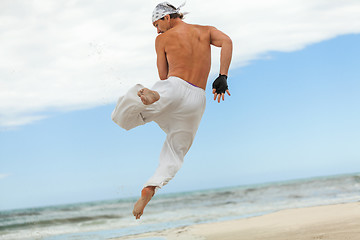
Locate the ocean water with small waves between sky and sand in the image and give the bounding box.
[0,173,360,240]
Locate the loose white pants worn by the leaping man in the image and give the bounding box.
[111,77,206,190]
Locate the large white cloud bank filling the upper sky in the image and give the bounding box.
[0,0,360,127]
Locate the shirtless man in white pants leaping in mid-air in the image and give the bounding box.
[112,2,232,219]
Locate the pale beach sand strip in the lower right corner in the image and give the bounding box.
[112,202,360,240]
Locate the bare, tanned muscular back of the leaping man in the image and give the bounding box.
[156,22,211,89]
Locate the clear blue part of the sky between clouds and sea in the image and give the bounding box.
[0,34,360,209]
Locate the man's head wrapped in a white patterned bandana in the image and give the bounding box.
[152,2,184,33]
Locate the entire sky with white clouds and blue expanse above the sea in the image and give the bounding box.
[0,0,360,210]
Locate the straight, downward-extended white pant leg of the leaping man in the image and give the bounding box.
[144,77,206,190]
